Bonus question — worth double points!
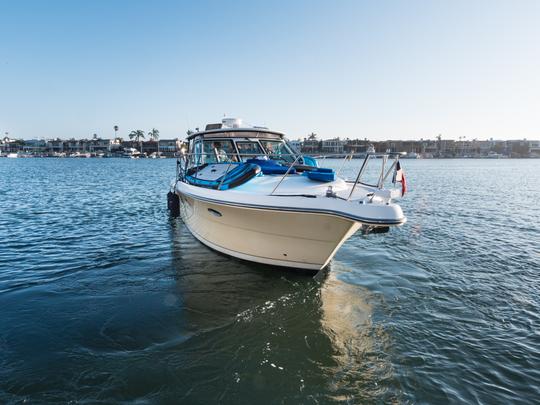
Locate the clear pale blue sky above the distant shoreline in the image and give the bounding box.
[0,0,540,140]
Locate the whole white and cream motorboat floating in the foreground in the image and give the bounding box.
[169,119,406,270]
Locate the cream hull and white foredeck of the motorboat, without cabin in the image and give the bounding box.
[175,176,405,270]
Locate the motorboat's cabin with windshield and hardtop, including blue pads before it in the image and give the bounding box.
[178,118,335,190]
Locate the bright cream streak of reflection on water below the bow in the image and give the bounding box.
[320,261,395,401]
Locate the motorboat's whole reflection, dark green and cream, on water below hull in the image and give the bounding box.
[166,221,393,402]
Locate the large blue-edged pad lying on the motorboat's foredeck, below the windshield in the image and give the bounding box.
[185,163,261,190]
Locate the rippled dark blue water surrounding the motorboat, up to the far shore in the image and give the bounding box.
[0,159,540,404]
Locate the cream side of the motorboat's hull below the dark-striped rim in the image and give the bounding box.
[177,191,361,270]
